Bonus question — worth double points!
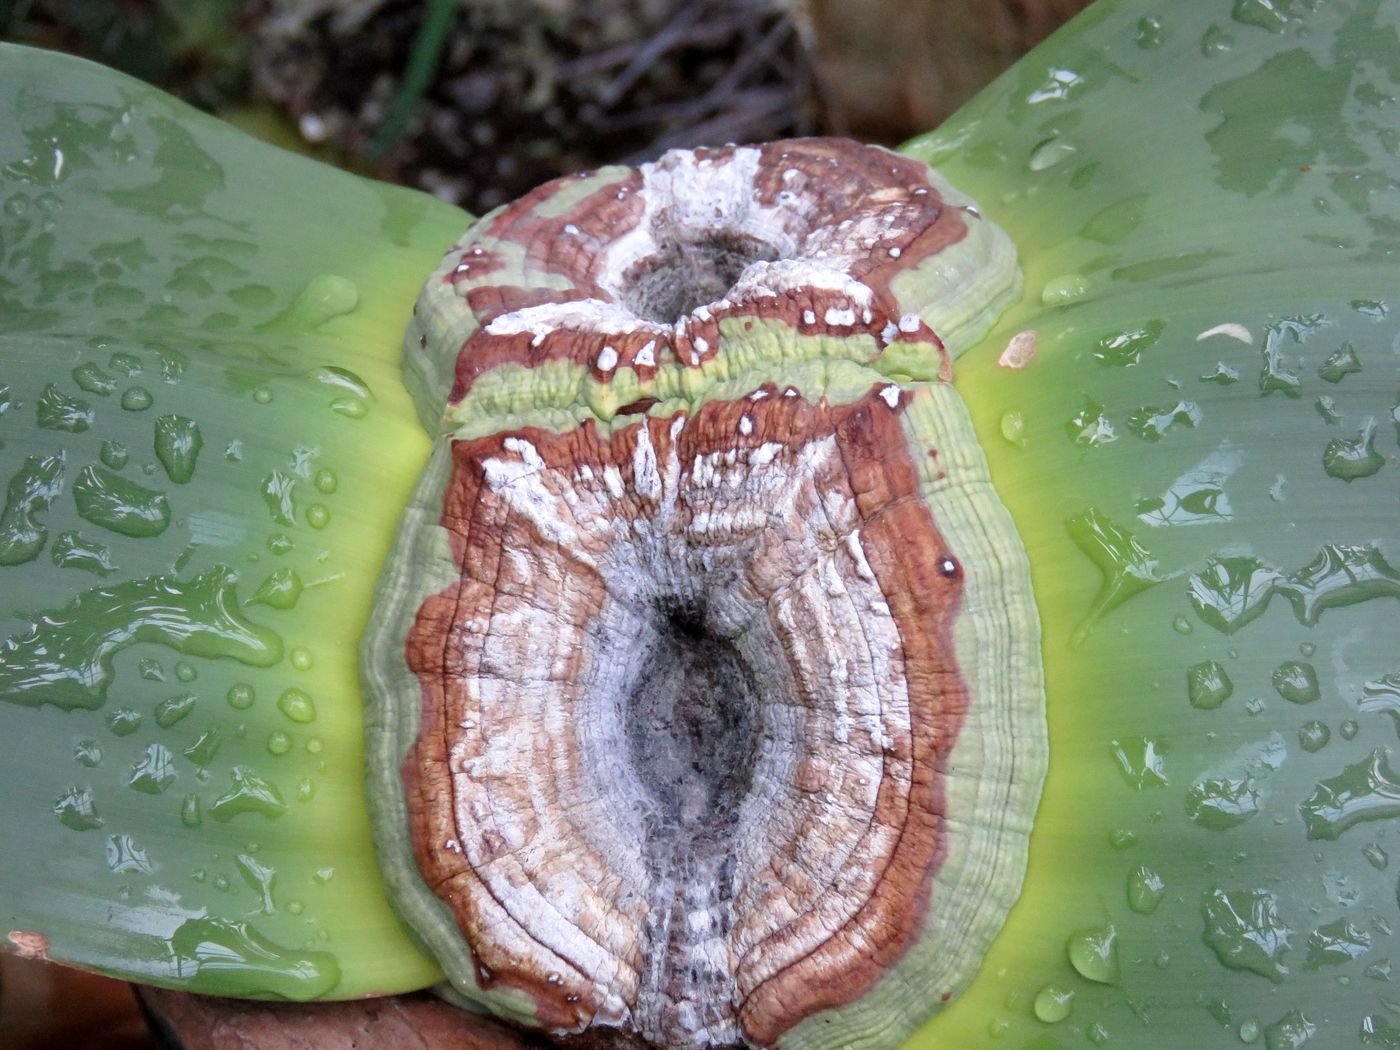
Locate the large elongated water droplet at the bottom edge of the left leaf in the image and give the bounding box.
[169,918,340,1002]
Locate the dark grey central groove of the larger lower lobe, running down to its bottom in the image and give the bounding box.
[626,606,760,1046]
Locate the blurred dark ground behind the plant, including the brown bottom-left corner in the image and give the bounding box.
[0,0,1089,1050]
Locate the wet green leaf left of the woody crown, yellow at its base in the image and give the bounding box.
[0,46,469,998]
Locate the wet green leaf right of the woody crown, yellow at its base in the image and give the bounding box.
[906,0,1400,1047]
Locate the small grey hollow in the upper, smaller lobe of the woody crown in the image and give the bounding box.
[622,232,778,325]
